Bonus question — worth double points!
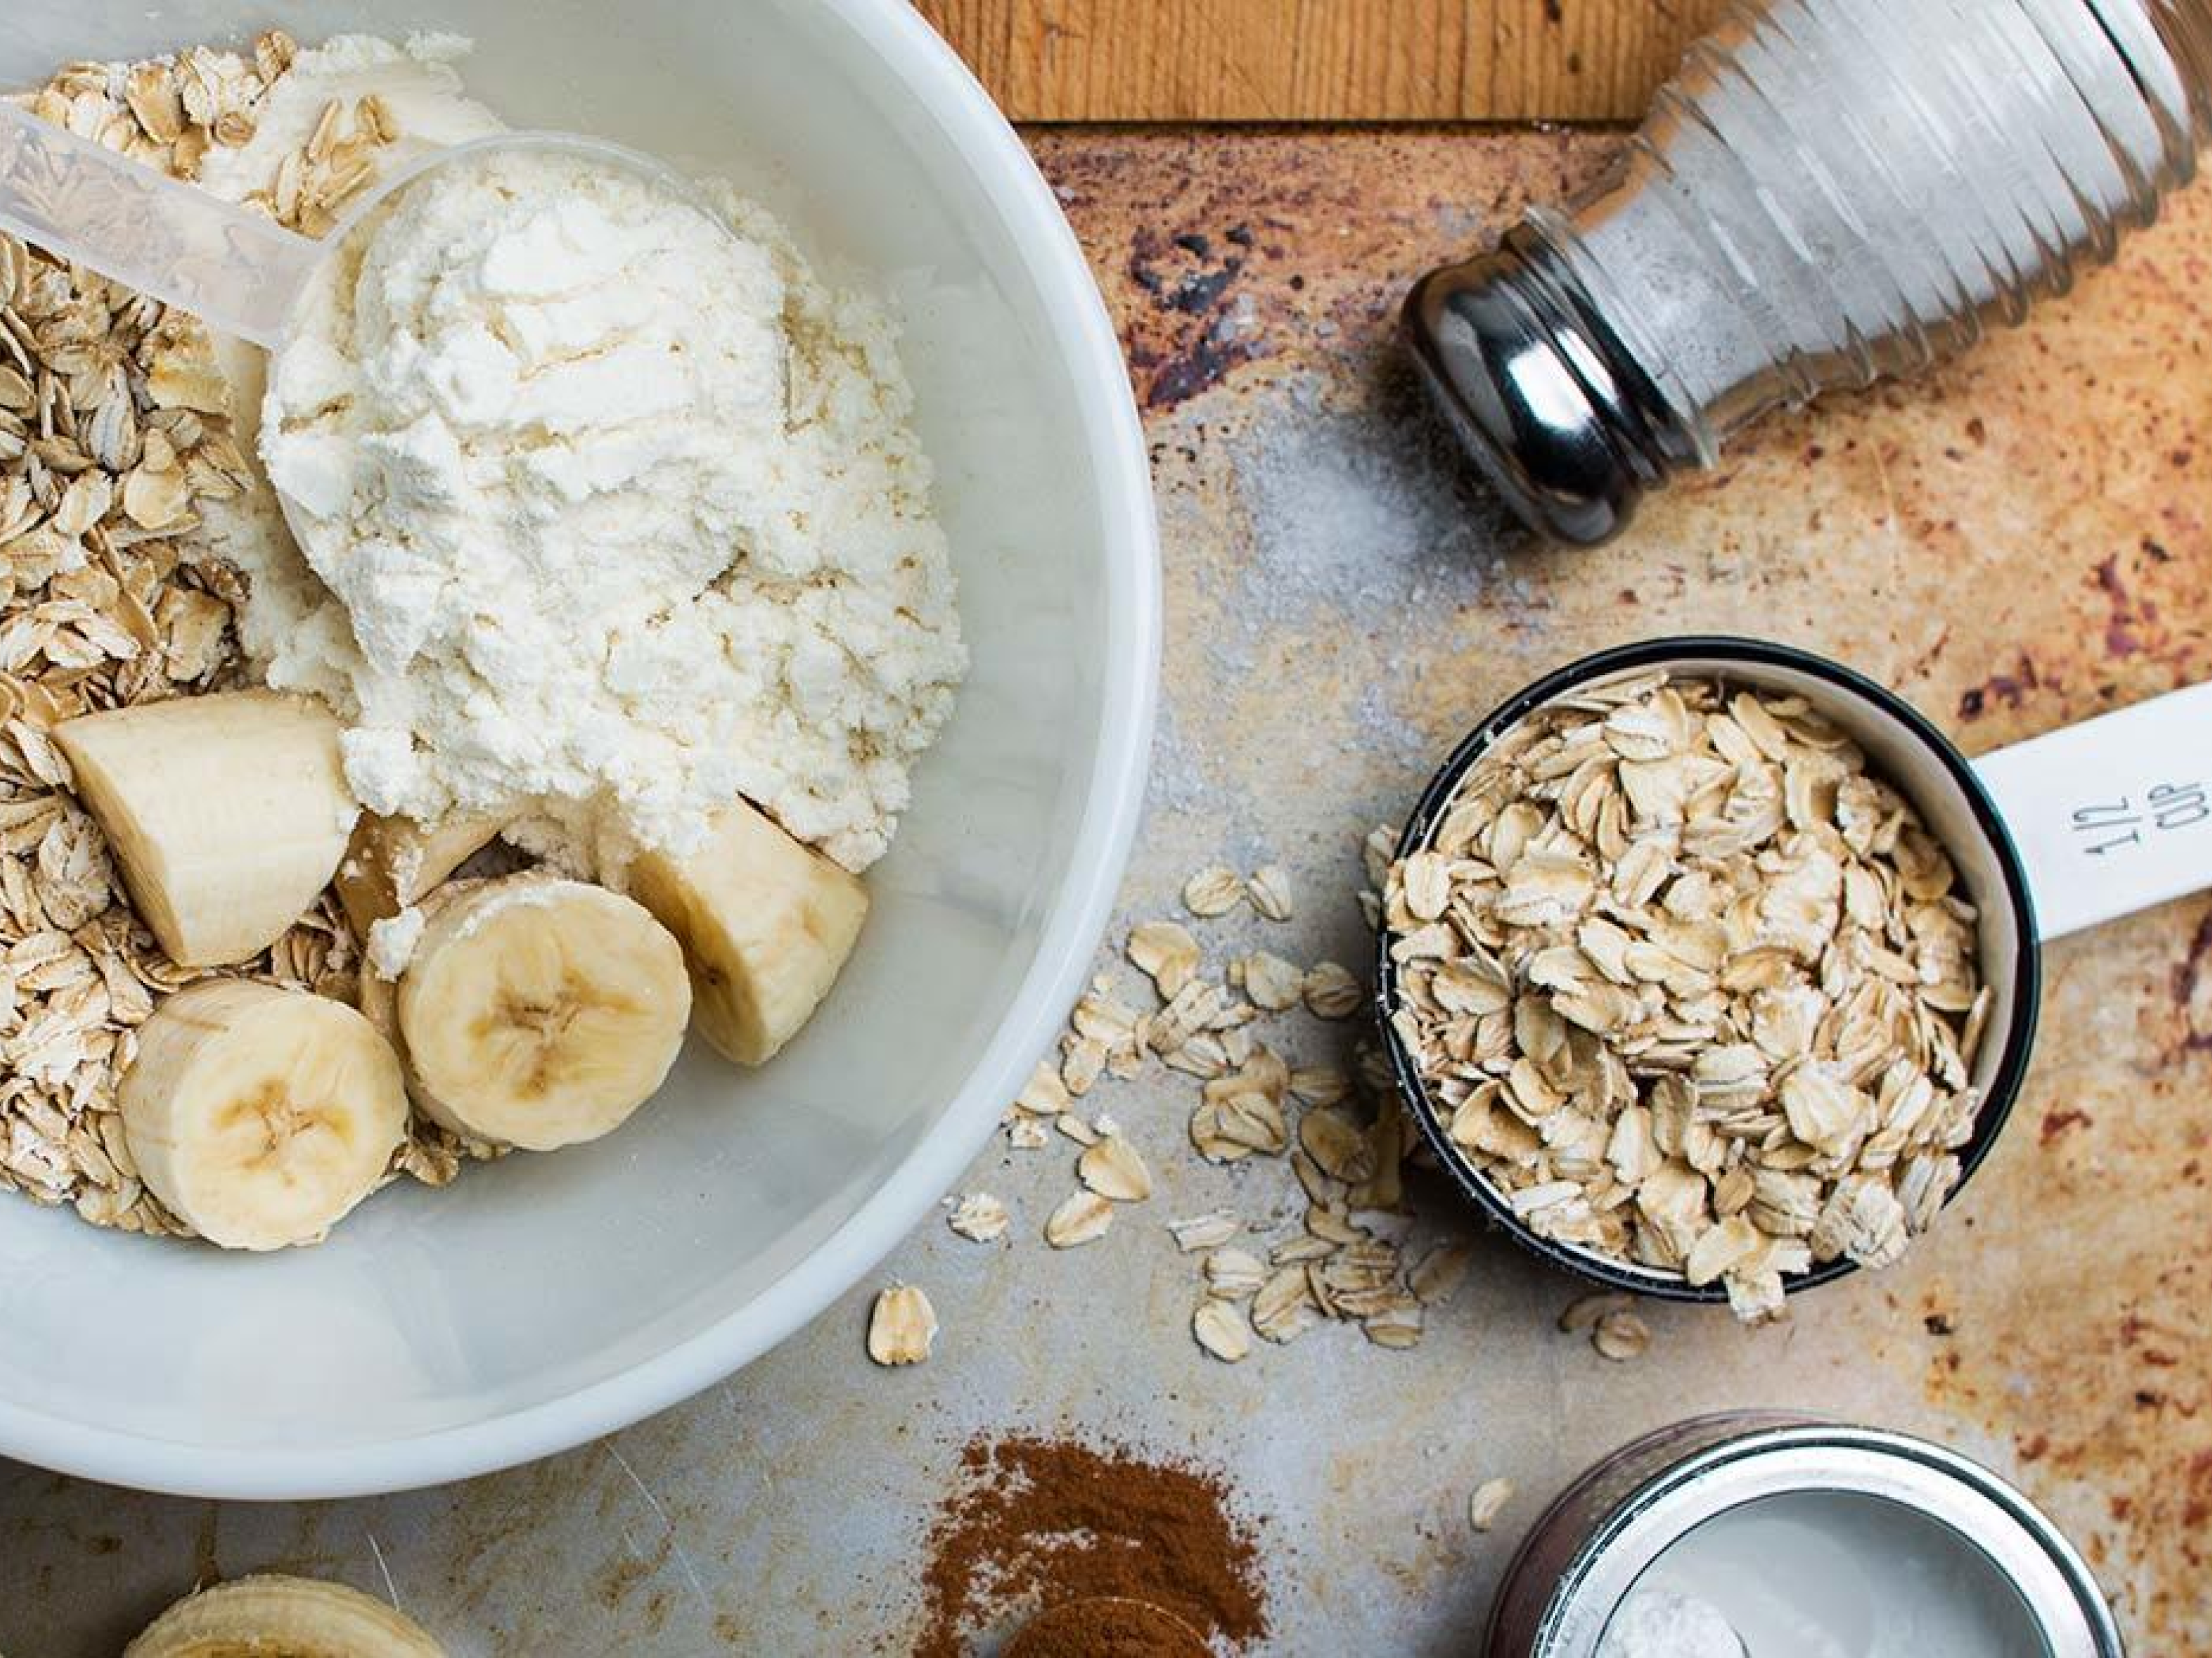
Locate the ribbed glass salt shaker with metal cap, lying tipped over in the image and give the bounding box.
[1404,0,2212,544]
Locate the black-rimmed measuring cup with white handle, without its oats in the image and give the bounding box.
[1376,635,2212,1302]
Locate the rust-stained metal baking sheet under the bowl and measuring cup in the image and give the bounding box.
[0,132,2212,1658]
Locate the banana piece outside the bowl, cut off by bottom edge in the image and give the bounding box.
[124,1574,445,1658]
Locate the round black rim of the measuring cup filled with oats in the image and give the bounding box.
[1376,635,2041,1302]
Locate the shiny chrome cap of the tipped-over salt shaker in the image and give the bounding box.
[1400,226,1670,546]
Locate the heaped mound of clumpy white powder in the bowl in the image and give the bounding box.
[249,128,967,875]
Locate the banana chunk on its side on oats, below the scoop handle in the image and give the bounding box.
[53,690,361,966]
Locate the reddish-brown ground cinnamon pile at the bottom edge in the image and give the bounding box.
[914,1437,1267,1658]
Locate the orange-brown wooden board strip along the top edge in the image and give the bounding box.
[918,0,1723,122]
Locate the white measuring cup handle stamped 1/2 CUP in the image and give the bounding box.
[1973,683,2212,939]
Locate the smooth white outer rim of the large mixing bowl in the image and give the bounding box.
[0,0,1161,1501]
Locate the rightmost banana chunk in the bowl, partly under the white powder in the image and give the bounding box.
[630,800,867,1065]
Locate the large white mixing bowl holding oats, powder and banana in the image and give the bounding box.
[0,0,1159,1497]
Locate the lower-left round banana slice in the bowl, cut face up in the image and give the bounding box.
[118,980,407,1249]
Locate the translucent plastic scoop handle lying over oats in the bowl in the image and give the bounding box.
[0,102,321,350]
